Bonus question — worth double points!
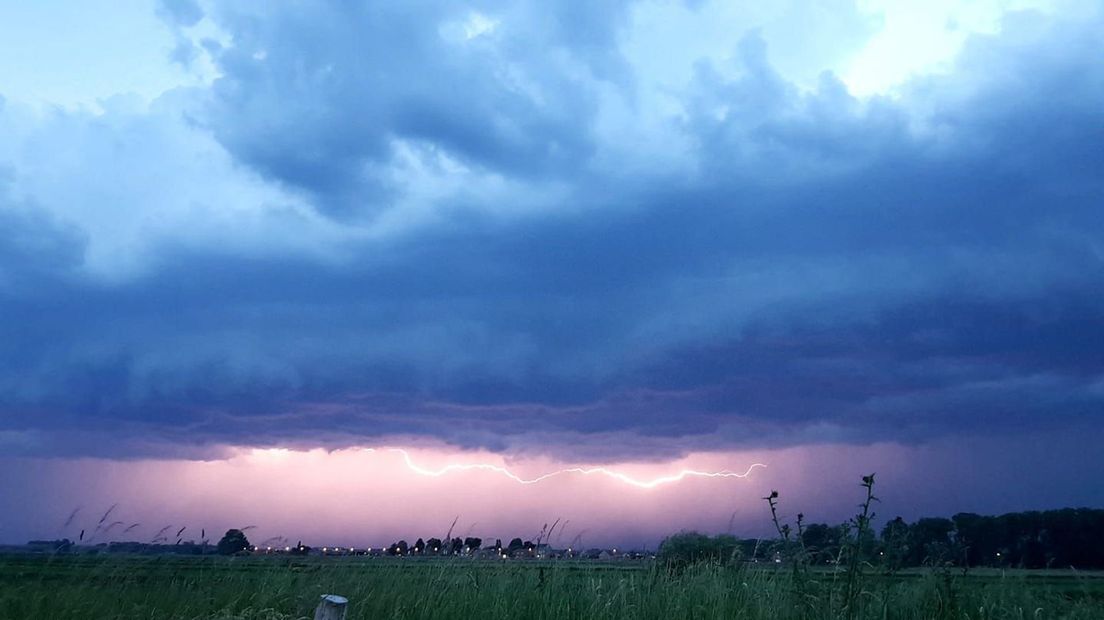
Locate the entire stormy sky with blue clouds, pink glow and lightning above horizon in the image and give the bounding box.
[0,0,1104,546]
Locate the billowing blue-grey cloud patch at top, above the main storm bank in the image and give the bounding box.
[198,2,626,218]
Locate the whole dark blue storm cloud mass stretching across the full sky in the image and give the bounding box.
[0,4,1104,458]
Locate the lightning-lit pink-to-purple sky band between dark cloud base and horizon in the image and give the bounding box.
[0,430,1099,547]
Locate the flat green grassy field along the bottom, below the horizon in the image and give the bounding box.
[0,556,1104,620]
